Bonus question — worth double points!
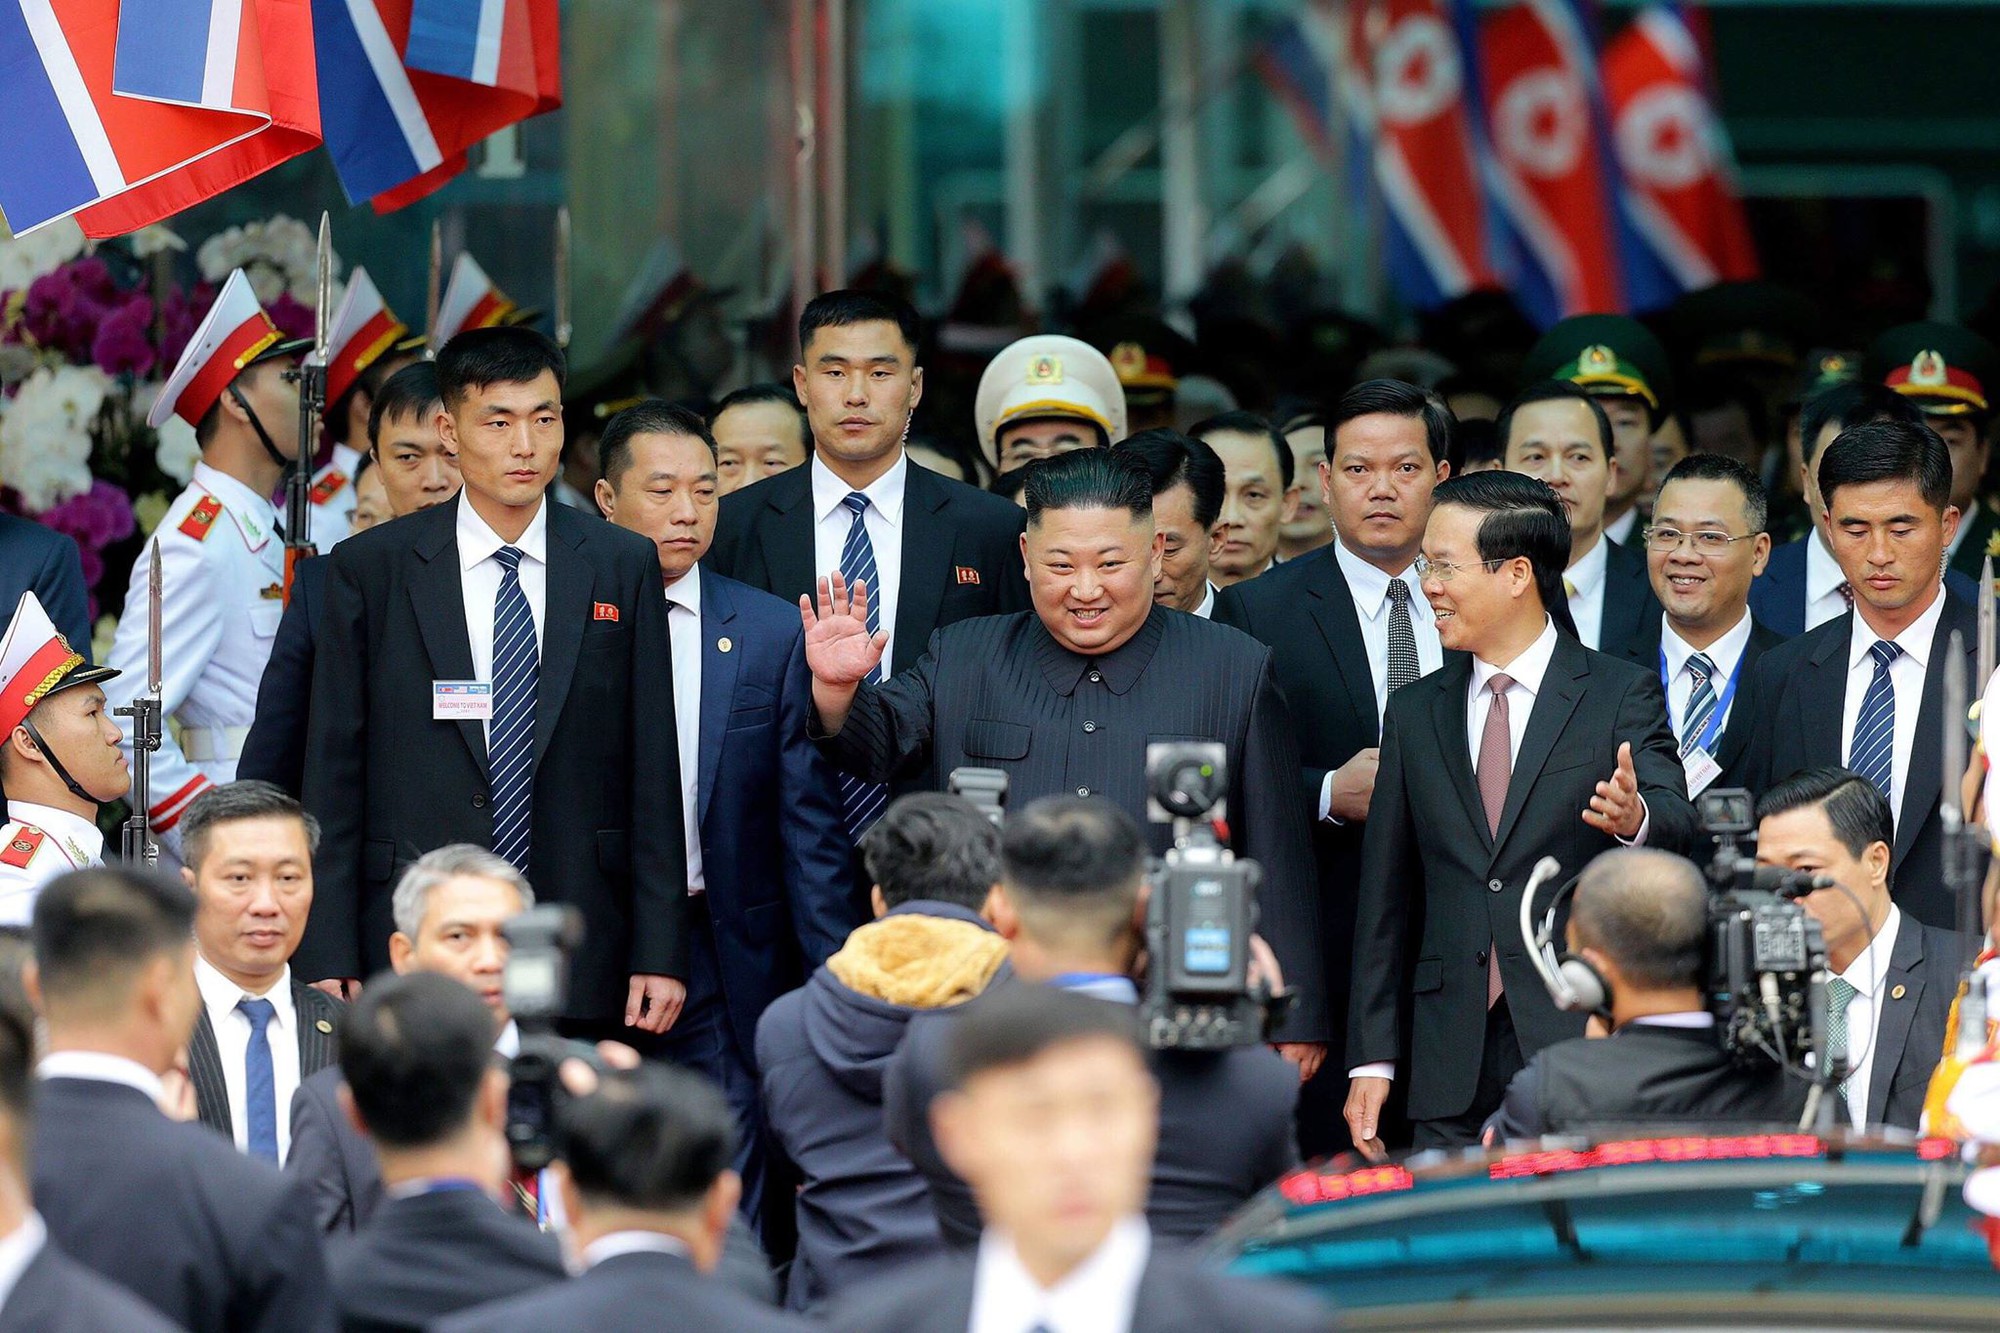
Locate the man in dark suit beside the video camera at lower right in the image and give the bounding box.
[1756,767,1974,1131]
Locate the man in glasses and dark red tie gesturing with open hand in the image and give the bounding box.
[1346,472,1696,1151]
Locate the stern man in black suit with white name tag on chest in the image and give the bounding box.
[294,328,688,1031]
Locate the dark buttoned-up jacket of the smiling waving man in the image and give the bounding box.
[822,606,1328,1041]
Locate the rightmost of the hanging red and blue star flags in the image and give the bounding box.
[1604,4,1758,296]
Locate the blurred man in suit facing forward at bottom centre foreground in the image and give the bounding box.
[832,987,1334,1333]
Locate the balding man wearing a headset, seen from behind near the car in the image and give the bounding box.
[1484,849,1806,1143]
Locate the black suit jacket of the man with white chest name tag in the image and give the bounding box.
[292,494,688,1021]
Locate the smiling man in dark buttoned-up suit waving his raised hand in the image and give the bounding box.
[804,448,1328,1040]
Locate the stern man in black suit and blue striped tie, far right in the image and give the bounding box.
[1748,420,1978,927]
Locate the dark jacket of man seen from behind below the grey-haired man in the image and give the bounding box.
[326,1189,566,1333]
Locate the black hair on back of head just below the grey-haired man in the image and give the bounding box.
[338,973,494,1149]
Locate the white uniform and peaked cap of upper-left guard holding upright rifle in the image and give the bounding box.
[106,270,300,855]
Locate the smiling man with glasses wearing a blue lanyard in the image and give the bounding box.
[1644,454,1784,797]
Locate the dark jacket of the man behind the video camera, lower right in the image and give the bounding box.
[1848,915,1978,1133]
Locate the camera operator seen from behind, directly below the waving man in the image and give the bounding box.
[884,797,1298,1247]
